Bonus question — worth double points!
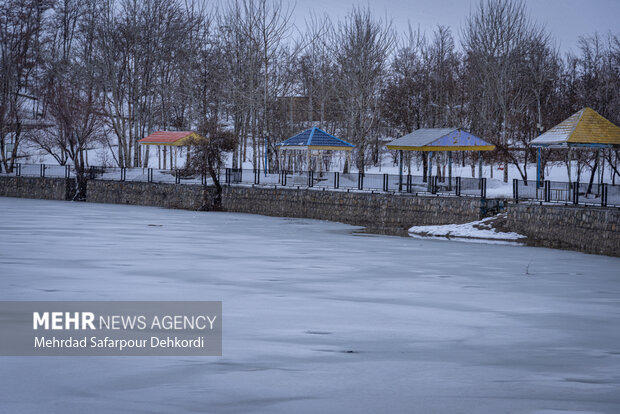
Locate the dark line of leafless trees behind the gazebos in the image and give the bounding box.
[0,0,620,183]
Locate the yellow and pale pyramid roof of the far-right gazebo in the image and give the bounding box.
[530,108,620,148]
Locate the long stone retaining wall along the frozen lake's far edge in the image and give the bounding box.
[0,177,620,256]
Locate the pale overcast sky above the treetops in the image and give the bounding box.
[282,0,620,52]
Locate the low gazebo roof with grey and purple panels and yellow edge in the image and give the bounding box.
[387,128,495,151]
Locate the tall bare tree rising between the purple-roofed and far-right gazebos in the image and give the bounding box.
[462,0,545,182]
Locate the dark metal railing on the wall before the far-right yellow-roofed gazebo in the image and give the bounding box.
[512,178,620,207]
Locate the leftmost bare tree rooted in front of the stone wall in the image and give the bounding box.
[35,0,102,199]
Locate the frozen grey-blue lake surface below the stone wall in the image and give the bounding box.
[0,198,620,414]
